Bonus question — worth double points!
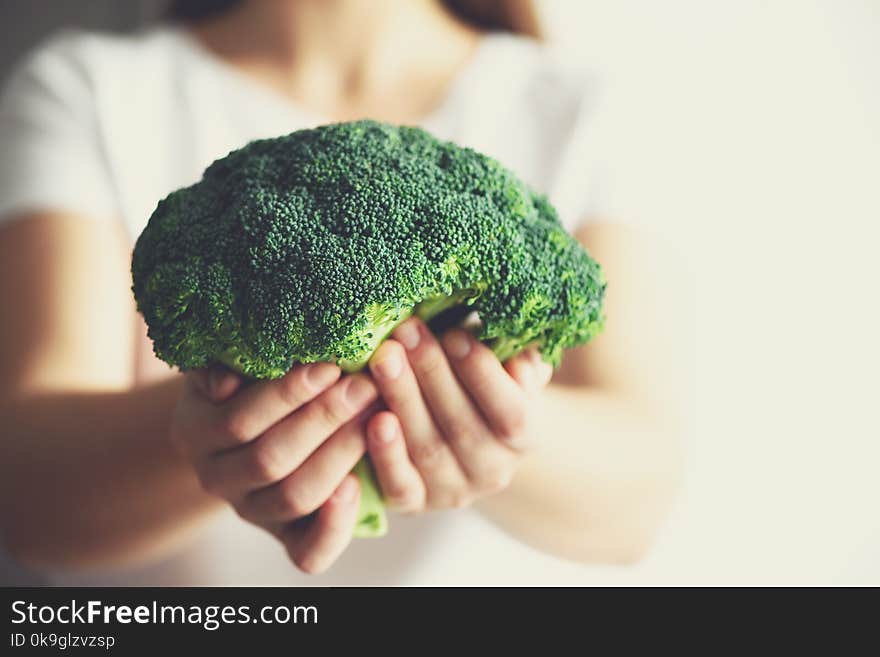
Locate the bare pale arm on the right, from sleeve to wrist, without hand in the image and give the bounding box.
[480,224,681,563]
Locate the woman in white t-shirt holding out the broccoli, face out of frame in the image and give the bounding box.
[0,0,677,584]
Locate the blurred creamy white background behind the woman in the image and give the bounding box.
[0,0,880,584]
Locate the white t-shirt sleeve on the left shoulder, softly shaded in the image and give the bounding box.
[0,33,117,222]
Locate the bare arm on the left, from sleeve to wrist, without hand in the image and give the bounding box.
[0,213,219,567]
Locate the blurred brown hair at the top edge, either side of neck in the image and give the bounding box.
[166,0,542,38]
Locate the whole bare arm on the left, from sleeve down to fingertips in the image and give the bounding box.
[0,214,388,572]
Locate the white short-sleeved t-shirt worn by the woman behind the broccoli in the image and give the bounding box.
[0,26,616,585]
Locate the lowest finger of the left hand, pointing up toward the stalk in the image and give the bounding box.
[281,475,360,575]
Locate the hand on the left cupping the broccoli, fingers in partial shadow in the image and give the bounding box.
[170,363,378,573]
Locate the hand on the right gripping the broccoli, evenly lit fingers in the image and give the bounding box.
[367,318,552,512]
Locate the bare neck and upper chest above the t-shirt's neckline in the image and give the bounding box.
[193,0,480,122]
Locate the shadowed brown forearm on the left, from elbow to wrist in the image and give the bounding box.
[0,378,219,568]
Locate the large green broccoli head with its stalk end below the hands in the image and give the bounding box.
[132,121,605,536]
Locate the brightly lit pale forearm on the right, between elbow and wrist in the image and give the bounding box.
[480,385,680,563]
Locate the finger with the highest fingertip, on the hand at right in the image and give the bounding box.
[386,324,514,490]
